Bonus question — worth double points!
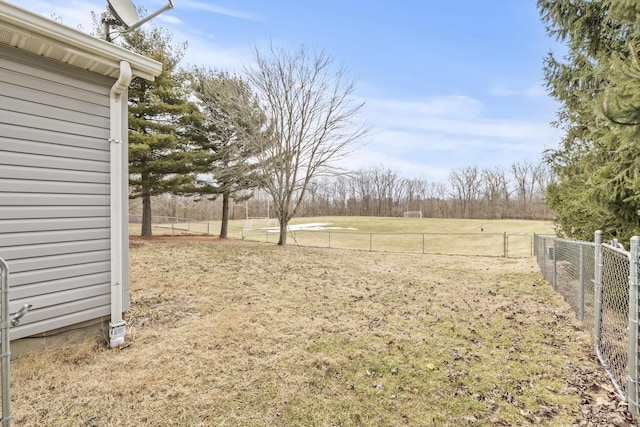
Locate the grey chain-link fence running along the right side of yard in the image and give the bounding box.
[534,232,640,415]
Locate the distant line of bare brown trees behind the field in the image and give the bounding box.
[133,161,554,221]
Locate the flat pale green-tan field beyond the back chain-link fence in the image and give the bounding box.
[130,217,554,257]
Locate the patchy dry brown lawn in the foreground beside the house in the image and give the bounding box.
[11,239,599,426]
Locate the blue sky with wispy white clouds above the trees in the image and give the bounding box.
[27,0,561,181]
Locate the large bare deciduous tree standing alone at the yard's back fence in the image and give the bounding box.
[246,44,368,245]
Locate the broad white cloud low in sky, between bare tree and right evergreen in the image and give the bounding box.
[346,95,559,182]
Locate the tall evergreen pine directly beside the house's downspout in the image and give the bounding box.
[124,26,208,236]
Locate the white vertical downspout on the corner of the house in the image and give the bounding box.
[109,61,132,347]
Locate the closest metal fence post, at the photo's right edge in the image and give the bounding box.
[627,236,640,415]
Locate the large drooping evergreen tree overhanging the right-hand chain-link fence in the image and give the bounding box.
[538,0,640,241]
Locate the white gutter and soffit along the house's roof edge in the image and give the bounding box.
[0,0,162,80]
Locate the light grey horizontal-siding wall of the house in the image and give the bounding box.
[0,44,129,339]
